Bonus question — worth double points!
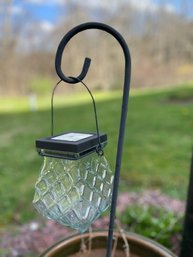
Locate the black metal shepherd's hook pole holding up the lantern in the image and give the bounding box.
[55,22,131,257]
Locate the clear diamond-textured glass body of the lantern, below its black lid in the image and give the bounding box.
[33,153,113,232]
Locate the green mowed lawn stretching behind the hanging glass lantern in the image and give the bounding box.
[0,85,193,227]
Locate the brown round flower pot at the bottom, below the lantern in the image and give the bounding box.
[40,231,176,257]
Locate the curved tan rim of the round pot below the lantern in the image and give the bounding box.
[39,230,177,257]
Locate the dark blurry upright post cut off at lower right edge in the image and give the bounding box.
[179,150,193,257]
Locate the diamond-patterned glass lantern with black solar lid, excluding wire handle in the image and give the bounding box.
[33,132,113,232]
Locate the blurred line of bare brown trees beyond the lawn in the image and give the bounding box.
[0,0,193,95]
